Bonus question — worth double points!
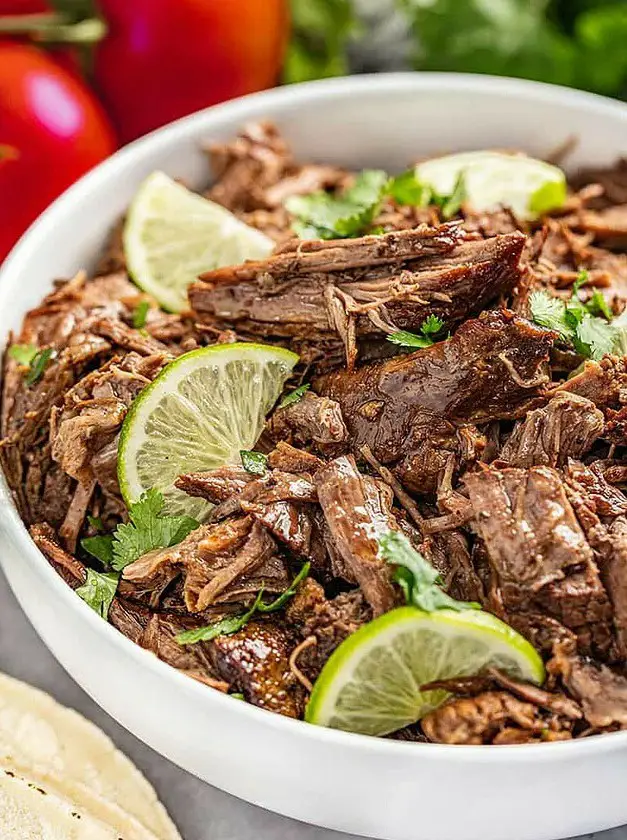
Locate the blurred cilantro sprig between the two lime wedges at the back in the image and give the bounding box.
[285,169,466,239]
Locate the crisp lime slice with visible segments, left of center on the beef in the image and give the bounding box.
[118,344,298,519]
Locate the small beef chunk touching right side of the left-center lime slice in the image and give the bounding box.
[267,391,348,455]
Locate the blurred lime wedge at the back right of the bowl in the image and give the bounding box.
[416,152,566,219]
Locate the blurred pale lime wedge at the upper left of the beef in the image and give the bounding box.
[124,172,274,312]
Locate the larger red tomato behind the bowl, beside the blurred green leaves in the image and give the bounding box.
[94,0,289,142]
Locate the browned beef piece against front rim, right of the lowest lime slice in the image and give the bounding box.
[421,691,571,744]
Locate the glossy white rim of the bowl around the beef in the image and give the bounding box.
[0,72,627,764]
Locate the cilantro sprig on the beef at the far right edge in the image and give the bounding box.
[529,271,627,361]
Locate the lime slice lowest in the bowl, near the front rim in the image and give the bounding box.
[305,607,544,735]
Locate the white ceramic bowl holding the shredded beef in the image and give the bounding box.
[0,73,627,840]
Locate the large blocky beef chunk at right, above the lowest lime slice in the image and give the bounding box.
[465,467,612,653]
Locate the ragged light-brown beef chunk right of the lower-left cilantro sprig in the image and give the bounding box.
[123,516,289,613]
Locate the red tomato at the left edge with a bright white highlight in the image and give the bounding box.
[0,41,115,262]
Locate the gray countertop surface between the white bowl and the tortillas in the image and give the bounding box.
[0,574,627,840]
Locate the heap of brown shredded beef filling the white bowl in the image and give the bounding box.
[6,123,627,749]
